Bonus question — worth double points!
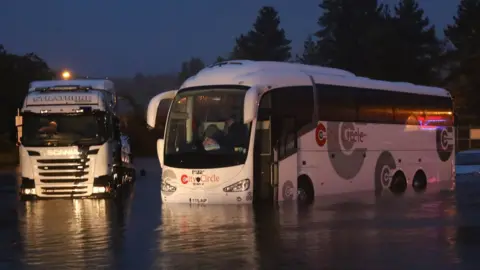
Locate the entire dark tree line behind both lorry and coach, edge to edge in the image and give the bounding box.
[0,0,480,160]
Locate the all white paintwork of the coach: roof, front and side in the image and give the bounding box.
[147,61,455,204]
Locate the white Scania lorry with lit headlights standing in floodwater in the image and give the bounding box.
[16,79,135,199]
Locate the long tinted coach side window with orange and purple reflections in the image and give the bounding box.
[316,84,453,126]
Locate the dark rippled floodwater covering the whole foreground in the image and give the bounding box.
[0,160,480,270]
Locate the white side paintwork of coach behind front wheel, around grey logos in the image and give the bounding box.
[298,122,454,196]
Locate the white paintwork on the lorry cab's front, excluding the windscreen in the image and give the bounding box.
[17,80,122,197]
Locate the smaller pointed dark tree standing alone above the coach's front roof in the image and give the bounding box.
[230,6,291,61]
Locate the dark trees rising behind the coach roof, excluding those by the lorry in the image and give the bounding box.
[179,0,480,122]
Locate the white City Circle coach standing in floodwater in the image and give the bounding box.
[147,61,455,204]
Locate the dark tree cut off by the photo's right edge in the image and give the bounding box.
[445,0,480,118]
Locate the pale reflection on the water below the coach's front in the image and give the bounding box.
[156,205,256,269]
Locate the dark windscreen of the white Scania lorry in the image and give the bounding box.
[22,113,108,146]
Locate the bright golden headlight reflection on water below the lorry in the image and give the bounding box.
[19,195,128,269]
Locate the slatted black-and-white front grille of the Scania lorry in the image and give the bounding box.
[36,158,90,197]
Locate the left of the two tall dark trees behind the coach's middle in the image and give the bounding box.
[300,0,384,77]
